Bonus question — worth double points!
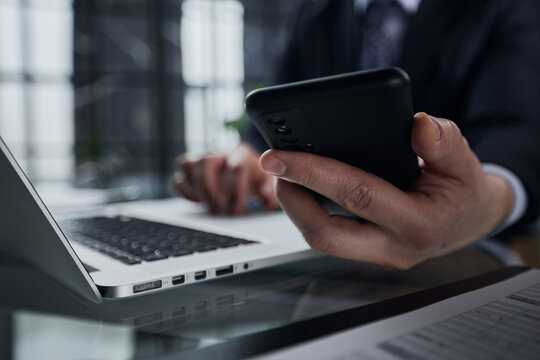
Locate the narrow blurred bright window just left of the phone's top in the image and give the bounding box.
[181,0,244,153]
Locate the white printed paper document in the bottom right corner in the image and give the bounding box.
[258,269,540,360]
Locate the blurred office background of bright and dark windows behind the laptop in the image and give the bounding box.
[0,0,304,200]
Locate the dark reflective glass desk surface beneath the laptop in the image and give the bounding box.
[0,240,502,359]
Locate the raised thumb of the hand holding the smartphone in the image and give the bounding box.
[411,113,478,178]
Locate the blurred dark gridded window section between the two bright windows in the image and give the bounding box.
[74,0,184,200]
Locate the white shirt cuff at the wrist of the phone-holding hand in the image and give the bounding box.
[482,163,528,235]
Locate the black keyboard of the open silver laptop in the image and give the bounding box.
[60,217,258,265]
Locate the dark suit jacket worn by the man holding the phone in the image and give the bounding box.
[246,0,540,229]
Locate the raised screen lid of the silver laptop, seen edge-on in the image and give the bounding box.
[0,137,102,303]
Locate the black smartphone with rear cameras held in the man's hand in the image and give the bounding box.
[244,67,420,215]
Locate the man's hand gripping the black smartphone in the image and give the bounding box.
[260,113,513,269]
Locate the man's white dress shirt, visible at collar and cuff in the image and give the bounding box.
[354,0,528,235]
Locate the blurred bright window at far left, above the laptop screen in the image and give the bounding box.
[0,0,74,182]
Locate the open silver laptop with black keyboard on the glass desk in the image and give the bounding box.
[0,138,317,302]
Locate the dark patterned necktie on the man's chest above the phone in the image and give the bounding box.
[360,0,407,69]
